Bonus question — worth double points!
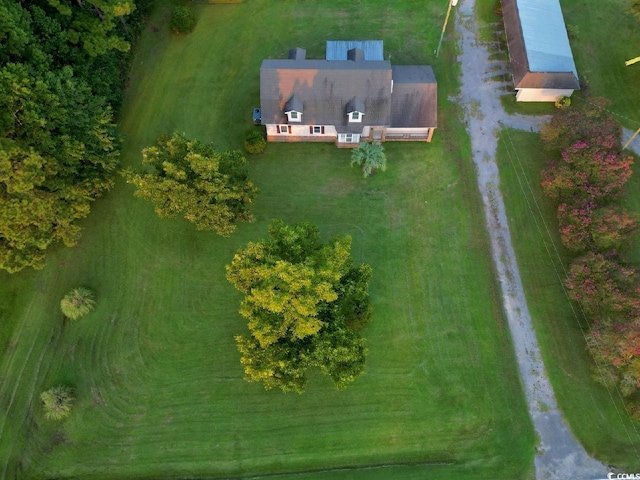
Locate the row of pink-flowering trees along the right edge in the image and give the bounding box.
[541,99,640,419]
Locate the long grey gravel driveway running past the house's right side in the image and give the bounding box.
[456,0,610,480]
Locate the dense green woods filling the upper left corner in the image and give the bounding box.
[0,0,153,272]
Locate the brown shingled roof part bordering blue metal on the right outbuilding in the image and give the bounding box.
[502,0,580,90]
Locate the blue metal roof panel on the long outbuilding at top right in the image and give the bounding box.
[518,0,578,78]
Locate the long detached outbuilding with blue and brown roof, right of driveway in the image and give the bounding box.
[502,0,580,102]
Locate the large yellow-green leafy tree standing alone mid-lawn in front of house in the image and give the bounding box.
[227,220,371,393]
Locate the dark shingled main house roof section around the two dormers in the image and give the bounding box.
[260,60,391,133]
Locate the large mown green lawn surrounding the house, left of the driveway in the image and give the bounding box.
[0,0,535,480]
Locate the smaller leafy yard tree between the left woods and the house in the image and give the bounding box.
[126,133,258,236]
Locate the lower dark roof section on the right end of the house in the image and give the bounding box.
[391,65,438,128]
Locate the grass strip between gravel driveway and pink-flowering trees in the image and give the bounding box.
[498,129,640,471]
